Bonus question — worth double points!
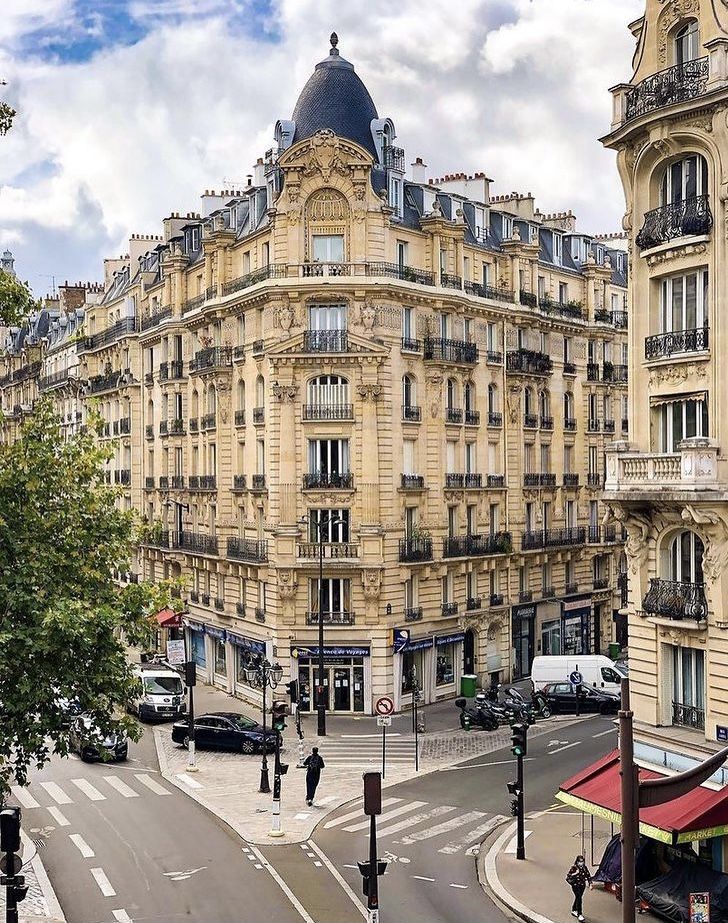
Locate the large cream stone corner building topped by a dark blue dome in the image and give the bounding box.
[54,36,628,714]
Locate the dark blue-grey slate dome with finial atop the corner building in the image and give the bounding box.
[293,32,378,160]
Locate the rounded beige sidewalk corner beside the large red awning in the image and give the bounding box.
[477,807,640,923]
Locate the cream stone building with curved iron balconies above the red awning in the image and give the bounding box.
[603,0,728,796]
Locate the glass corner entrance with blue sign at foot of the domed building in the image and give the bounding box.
[291,645,372,714]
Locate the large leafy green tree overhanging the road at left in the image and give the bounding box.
[0,401,175,803]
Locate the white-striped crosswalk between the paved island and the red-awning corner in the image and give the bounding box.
[324,798,505,855]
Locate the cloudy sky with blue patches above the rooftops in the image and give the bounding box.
[0,0,644,296]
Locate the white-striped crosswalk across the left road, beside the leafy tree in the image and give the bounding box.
[11,772,172,817]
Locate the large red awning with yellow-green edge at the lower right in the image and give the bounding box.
[556,750,728,844]
